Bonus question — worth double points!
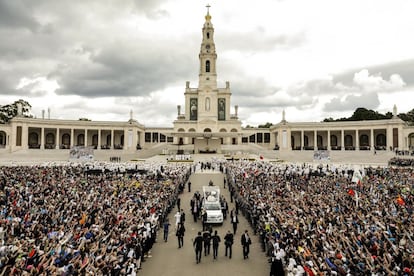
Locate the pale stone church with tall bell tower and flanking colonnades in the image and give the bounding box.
[0,11,414,153]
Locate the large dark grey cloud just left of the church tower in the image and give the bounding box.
[53,41,195,98]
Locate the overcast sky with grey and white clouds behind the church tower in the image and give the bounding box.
[0,0,414,127]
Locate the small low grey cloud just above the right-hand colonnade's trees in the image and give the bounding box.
[323,92,380,112]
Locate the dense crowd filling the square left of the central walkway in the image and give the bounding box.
[0,164,190,275]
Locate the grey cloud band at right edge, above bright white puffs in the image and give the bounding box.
[333,59,414,86]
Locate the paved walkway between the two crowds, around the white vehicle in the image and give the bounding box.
[139,169,270,276]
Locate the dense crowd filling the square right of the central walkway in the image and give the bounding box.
[227,162,414,275]
